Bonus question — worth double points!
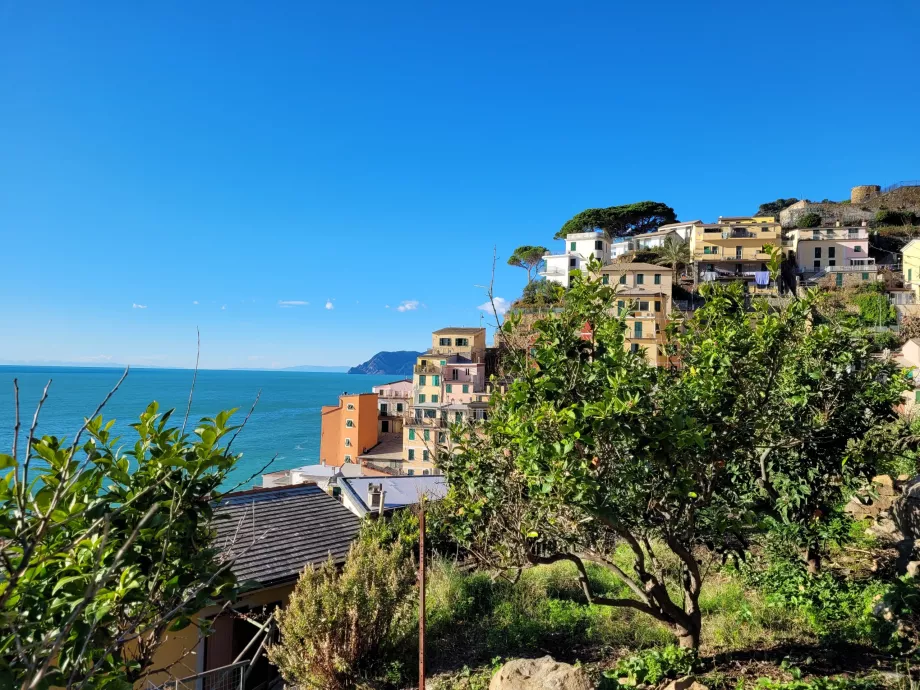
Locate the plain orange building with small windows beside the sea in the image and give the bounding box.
[319,393,377,467]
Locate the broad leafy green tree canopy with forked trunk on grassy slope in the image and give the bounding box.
[442,275,906,647]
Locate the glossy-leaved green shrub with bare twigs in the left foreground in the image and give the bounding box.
[0,382,244,690]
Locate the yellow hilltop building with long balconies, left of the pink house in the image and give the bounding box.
[690,216,782,283]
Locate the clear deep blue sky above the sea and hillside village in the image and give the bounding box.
[0,0,920,368]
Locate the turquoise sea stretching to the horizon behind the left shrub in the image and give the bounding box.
[0,366,399,488]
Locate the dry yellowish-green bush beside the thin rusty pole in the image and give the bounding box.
[268,539,415,690]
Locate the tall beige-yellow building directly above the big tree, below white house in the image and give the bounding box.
[600,263,674,366]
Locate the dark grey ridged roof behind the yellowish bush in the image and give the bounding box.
[215,484,360,587]
